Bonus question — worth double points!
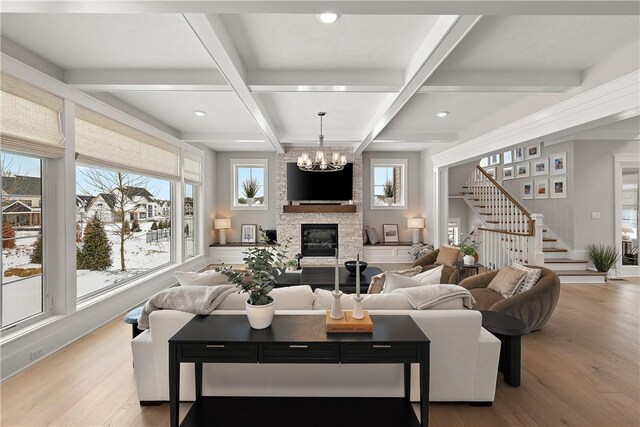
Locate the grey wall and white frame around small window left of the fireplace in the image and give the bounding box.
[212,151,277,242]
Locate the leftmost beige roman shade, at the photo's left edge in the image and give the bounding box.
[0,73,64,158]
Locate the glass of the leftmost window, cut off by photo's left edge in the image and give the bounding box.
[0,151,46,328]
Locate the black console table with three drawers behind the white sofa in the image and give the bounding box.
[169,315,430,427]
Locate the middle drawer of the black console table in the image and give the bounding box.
[260,343,340,363]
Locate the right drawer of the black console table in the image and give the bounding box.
[341,343,420,363]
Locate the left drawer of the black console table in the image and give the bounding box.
[182,344,258,363]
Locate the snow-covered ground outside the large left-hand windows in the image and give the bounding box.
[2,222,171,325]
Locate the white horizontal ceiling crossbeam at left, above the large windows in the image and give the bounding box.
[64,70,233,92]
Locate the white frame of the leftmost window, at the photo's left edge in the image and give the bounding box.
[0,151,50,333]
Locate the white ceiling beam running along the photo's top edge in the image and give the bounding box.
[2,0,640,16]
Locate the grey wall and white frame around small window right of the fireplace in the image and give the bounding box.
[362,151,424,242]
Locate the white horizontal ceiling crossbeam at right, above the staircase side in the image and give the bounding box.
[419,70,582,93]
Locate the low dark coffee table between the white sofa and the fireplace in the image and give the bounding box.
[276,267,383,294]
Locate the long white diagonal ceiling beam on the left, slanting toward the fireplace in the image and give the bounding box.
[183,14,284,153]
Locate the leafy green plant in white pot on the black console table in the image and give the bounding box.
[217,227,289,329]
